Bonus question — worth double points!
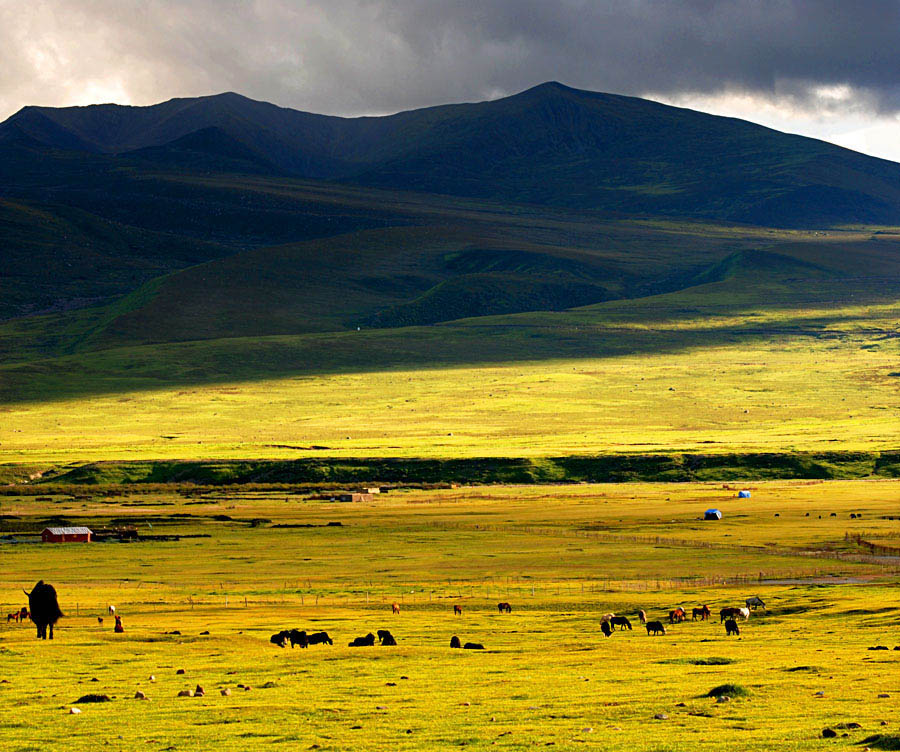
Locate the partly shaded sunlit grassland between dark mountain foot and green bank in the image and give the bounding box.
[0,296,900,463]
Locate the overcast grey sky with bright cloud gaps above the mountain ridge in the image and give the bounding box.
[0,0,900,161]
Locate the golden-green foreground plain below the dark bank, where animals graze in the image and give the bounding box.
[0,481,900,751]
